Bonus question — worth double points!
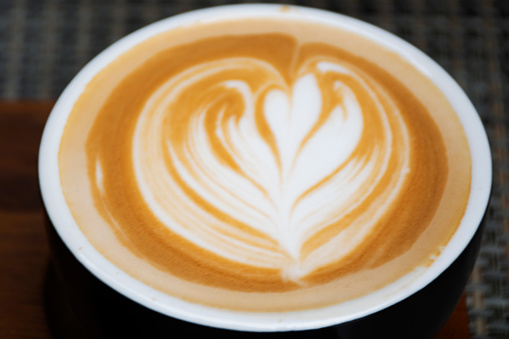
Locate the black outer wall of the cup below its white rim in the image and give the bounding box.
[41,201,485,339]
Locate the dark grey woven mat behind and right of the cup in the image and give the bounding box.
[0,0,509,339]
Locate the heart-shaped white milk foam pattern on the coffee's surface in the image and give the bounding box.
[132,58,409,281]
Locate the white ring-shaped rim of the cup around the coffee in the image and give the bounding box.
[38,4,492,332]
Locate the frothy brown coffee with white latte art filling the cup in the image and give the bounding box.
[59,16,471,312]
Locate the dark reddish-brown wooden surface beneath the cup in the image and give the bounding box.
[0,102,470,339]
